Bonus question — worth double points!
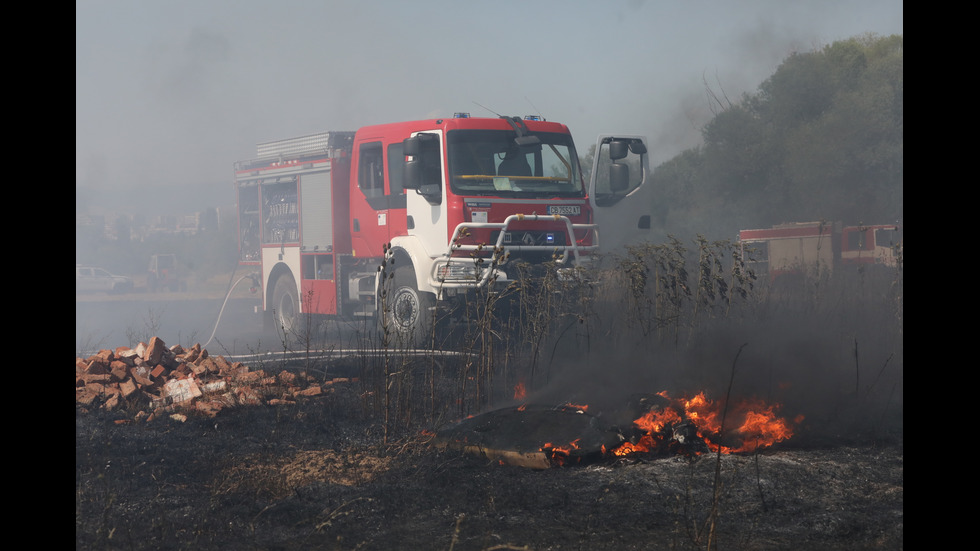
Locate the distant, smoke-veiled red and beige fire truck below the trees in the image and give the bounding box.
[738,222,902,280]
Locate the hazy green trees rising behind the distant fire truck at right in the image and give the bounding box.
[636,35,904,239]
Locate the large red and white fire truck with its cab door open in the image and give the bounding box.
[234,113,652,339]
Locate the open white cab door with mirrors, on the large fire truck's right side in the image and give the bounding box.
[589,135,653,254]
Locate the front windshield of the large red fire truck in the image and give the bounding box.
[447,130,585,197]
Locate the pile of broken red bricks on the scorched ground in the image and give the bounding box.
[75,337,347,420]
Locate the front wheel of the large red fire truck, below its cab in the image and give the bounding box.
[382,266,436,346]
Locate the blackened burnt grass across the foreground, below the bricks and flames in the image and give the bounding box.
[75,376,903,550]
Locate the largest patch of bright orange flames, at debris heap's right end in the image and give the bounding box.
[612,392,803,456]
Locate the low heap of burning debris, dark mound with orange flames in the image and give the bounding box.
[435,392,802,469]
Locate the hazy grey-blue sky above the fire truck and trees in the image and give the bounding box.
[75,0,903,206]
